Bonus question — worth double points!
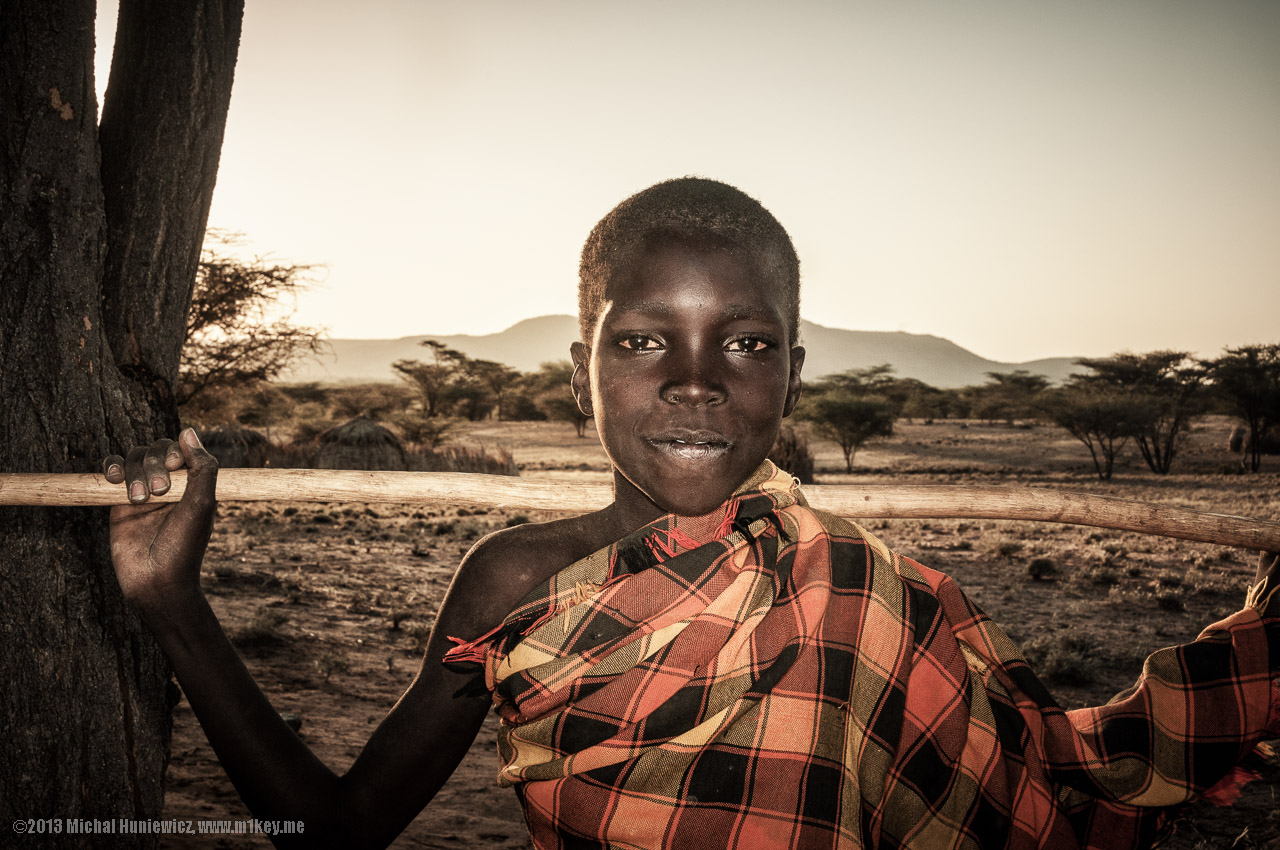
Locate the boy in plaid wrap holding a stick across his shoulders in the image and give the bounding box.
[105,178,1280,849]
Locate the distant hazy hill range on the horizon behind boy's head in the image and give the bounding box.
[285,315,1076,387]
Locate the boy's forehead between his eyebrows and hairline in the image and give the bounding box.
[604,241,787,324]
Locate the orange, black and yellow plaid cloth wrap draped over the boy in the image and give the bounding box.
[445,462,1280,850]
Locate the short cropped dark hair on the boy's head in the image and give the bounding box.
[577,177,800,344]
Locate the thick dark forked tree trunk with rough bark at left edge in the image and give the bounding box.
[0,0,242,846]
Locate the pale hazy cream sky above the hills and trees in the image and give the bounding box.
[97,0,1280,362]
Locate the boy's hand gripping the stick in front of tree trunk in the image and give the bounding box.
[102,428,218,616]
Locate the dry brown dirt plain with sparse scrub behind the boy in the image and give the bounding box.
[154,417,1280,850]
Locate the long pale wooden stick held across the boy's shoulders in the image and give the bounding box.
[0,469,1280,552]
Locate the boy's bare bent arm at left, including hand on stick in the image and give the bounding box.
[106,431,518,847]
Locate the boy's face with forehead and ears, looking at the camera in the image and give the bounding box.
[573,243,804,516]
